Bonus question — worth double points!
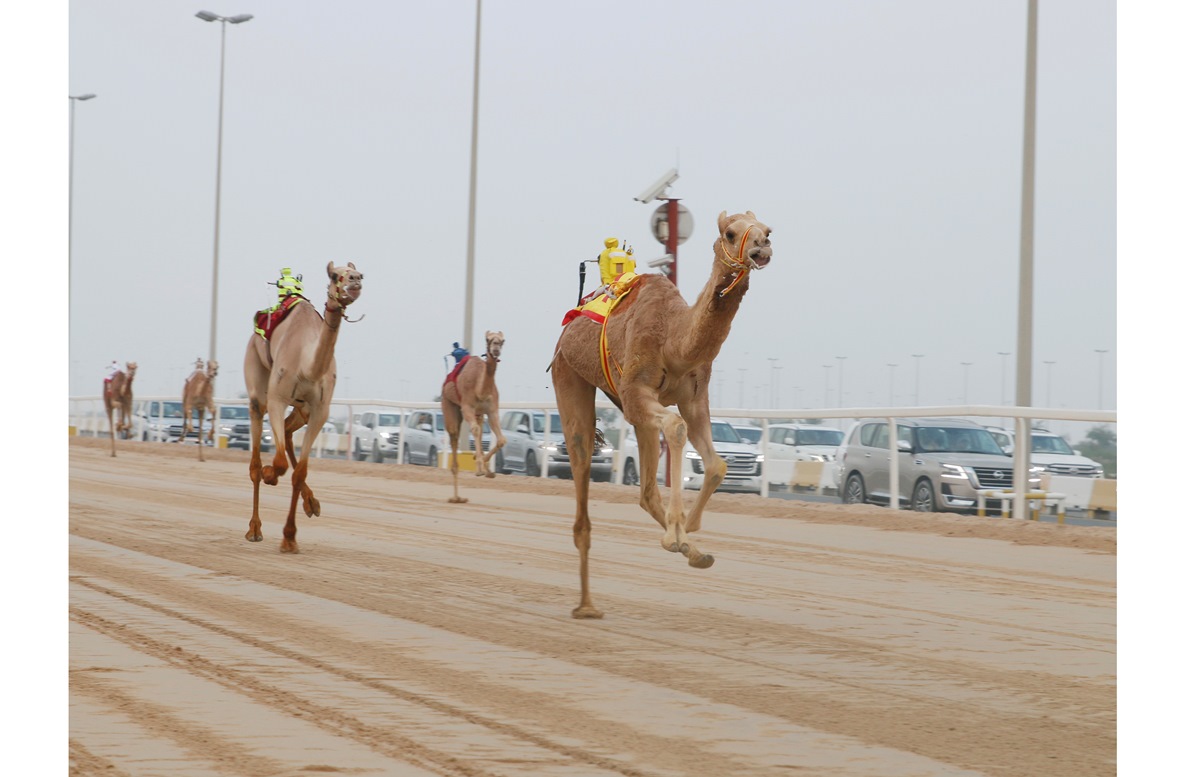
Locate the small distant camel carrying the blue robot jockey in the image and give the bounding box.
[442,332,505,504]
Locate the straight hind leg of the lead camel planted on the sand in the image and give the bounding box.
[551,359,604,619]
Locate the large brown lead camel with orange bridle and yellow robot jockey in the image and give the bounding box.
[551,211,772,618]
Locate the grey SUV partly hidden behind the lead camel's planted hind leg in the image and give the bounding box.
[496,410,612,482]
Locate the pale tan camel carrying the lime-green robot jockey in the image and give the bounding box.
[242,261,362,553]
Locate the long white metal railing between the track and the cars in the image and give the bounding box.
[68,394,1117,519]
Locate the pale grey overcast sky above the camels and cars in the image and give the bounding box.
[63,0,1118,422]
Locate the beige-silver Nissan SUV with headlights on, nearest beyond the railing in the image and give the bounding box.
[836,418,1042,512]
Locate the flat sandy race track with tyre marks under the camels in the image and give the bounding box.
[70,438,1116,777]
